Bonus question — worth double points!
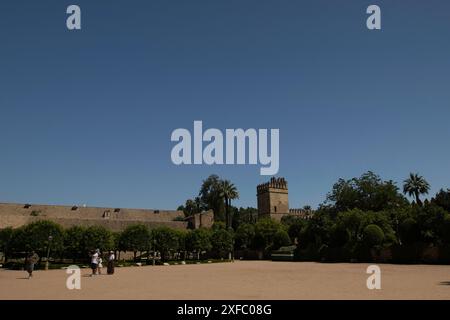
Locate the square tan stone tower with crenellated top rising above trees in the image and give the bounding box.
[256,178,289,221]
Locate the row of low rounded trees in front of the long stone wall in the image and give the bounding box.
[0,220,239,260]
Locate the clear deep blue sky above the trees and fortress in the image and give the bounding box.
[0,0,450,209]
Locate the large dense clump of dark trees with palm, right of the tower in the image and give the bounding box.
[283,172,450,262]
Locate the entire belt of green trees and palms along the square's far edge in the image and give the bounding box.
[0,172,450,262]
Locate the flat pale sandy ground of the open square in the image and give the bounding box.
[0,261,450,300]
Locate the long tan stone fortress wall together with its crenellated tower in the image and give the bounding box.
[0,178,313,231]
